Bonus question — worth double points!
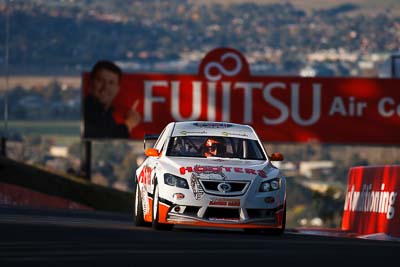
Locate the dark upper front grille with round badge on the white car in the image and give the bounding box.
[200,180,250,196]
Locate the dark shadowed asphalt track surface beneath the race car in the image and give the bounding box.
[0,207,400,267]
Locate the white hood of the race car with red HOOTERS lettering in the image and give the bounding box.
[161,158,280,181]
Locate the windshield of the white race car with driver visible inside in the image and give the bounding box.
[166,136,266,160]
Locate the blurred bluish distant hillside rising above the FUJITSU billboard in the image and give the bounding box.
[0,0,400,76]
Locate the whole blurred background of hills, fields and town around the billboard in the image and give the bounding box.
[0,0,400,229]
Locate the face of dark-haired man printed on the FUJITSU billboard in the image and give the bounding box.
[91,69,119,108]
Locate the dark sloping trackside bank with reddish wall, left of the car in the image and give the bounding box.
[0,156,133,213]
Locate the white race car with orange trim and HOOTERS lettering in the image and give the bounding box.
[134,121,286,234]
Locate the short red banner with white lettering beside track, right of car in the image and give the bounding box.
[342,165,400,240]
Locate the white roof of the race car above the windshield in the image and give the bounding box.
[172,121,258,140]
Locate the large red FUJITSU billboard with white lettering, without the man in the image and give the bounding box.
[83,48,400,144]
